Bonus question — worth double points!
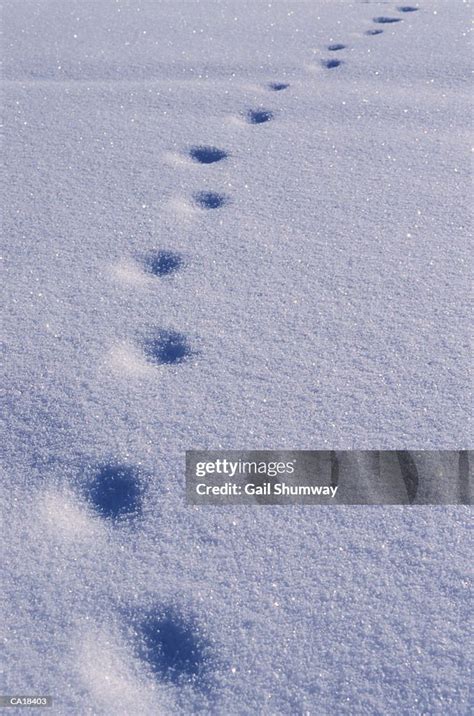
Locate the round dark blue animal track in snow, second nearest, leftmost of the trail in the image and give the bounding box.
[87,464,143,521]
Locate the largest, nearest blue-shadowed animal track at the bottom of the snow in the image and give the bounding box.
[132,609,209,686]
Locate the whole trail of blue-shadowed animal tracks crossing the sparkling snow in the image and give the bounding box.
[77,0,418,689]
